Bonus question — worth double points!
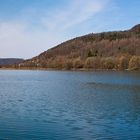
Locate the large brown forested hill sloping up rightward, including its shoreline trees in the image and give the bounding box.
[16,24,140,70]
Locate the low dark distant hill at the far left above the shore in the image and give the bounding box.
[0,58,23,67]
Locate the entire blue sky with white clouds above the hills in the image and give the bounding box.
[0,0,140,59]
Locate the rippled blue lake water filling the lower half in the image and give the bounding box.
[0,70,140,140]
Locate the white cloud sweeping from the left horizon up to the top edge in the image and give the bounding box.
[0,0,107,58]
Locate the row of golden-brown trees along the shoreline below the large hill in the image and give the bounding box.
[15,55,140,70]
